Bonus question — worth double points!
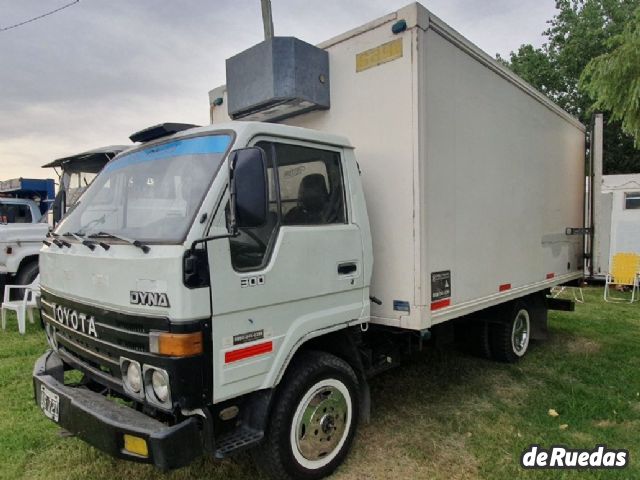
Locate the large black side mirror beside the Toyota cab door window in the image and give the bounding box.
[229,147,269,230]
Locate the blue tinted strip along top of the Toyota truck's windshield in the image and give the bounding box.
[104,135,231,172]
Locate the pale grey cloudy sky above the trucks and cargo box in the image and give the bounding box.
[0,0,555,180]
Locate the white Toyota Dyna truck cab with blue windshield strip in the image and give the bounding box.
[34,122,373,476]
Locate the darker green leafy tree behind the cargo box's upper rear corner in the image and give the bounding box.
[499,0,640,174]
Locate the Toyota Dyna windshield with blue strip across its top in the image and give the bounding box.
[56,135,231,243]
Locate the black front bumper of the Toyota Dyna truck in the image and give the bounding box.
[33,351,204,470]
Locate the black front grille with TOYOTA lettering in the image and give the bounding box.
[41,290,169,391]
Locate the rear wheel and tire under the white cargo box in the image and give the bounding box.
[489,301,531,363]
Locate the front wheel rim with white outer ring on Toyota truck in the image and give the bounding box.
[291,379,352,469]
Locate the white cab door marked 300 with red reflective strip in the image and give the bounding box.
[208,138,364,401]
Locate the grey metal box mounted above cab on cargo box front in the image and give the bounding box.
[227,37,330,121]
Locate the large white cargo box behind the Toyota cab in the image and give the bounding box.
[210,4,585,329]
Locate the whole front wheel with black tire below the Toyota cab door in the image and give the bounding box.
[256,351,360,480]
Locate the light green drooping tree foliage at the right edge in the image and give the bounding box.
[580,8,640,142]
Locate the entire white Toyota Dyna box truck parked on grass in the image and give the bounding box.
[33,4,588,479]
